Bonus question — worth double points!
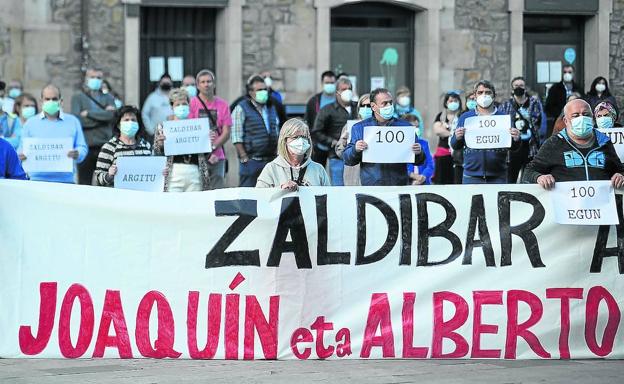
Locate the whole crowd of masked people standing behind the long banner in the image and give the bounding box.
[0,65,624,192]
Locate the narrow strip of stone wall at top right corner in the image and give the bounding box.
[609,0,624,109]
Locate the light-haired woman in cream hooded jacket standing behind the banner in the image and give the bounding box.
[256,119,330,191]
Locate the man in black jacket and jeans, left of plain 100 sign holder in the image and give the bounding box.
[312,77,358,186]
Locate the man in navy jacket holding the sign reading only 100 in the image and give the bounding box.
[342,88,425,186]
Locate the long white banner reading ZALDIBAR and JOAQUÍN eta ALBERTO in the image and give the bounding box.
[0,180,624,359]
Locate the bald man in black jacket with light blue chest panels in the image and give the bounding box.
[523,99,624,189]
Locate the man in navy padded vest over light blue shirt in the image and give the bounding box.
[232,75,280,187]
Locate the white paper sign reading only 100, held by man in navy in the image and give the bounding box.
[362,126,416,164]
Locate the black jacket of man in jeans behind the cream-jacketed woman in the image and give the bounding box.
[311,102,357,158]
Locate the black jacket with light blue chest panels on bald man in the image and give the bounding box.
[522,129,624,183]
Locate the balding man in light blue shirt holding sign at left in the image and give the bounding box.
[18,84,89,184]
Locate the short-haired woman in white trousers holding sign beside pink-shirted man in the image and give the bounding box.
[154,88,210,192]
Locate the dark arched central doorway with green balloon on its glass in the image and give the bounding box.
[330,2,414,95]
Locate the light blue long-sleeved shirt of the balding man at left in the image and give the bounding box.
[20,112,89,183]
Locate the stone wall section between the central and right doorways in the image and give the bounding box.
[454,0,516,99]
